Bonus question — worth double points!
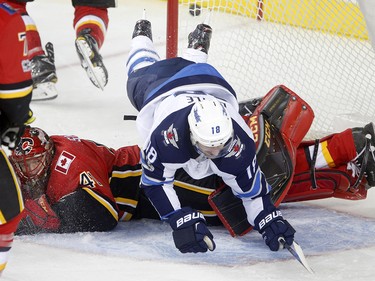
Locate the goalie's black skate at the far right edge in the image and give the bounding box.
[353,122,375,187]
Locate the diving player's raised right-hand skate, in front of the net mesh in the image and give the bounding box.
[188,23,212,54]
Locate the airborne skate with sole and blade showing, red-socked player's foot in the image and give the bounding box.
[75,29,108,90]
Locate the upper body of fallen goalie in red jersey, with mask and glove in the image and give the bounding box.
[10,128,150,234]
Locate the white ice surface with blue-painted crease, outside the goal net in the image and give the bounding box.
[2,0,375,281]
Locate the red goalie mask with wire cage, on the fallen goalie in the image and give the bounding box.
[9,127,54,198]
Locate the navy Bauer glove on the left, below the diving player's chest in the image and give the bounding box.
[168,207,216,253]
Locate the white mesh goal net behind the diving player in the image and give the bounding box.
[168,0,375,137]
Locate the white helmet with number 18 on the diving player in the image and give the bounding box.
[188,99,233,159]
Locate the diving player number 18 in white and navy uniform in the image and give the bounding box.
[126,20,295,253]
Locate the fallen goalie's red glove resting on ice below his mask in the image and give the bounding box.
[16,195,60,235]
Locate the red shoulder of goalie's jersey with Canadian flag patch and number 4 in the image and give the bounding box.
[47,136,115,204]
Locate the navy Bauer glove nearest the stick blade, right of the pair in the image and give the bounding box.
[254,207,296,251]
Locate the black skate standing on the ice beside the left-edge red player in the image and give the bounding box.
[30,42,58,101]
